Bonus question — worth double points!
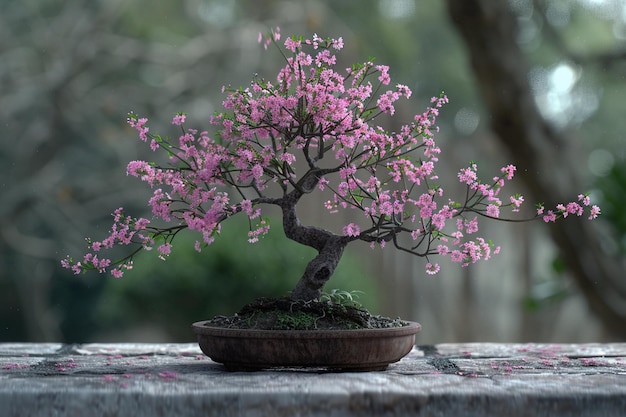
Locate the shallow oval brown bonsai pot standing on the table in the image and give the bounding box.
[192,321,422,371]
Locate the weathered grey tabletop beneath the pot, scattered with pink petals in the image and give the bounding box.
[0,343,626,417]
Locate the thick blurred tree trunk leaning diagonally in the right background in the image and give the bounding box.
[447,0,626,339]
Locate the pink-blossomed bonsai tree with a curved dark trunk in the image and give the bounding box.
[62,30,600,300]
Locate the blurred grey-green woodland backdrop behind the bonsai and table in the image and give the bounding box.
[0,0,626,344]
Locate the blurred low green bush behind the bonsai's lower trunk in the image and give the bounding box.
[92,218,377,341]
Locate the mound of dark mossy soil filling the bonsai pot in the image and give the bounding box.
[206,298,407,330]
